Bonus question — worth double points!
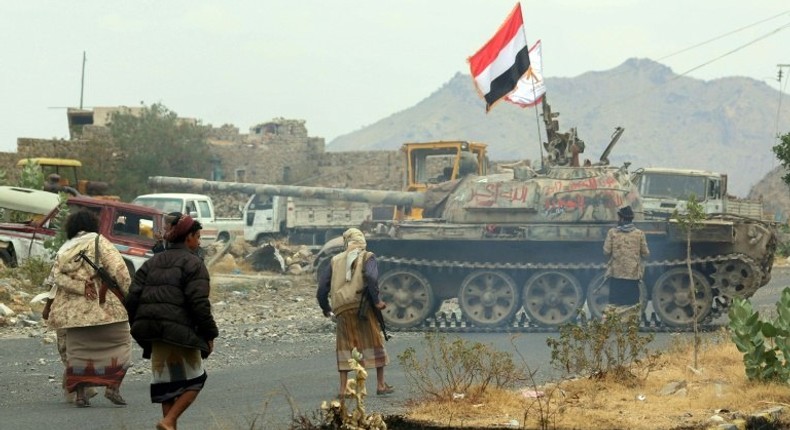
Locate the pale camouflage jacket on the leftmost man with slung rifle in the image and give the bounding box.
[47,233,132,329]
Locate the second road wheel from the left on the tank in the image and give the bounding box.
[458,271,520,327]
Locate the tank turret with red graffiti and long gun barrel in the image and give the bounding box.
[153,166,641,224]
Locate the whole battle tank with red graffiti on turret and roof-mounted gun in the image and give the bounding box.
[149,105,777,329]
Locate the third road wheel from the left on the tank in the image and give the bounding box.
[522,271,584,327]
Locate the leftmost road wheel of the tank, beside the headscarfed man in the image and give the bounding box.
[379,269,435,328]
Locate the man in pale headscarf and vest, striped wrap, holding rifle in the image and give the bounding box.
[316,228,394,397]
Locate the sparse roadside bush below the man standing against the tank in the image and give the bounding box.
[546,309,656,382]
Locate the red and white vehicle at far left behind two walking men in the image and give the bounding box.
[0,186,163,274]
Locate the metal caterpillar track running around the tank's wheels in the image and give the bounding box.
[376,253,763,333]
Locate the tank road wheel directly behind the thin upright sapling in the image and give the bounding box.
[653,267,713,327]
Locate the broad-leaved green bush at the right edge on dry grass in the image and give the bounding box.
[728,287,790,383]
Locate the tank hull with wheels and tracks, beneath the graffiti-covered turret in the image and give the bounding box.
[317,219,775,329]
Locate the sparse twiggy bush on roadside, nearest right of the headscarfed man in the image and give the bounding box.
[398,333,525,399]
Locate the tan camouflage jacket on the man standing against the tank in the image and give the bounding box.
[603,224,650,279]
